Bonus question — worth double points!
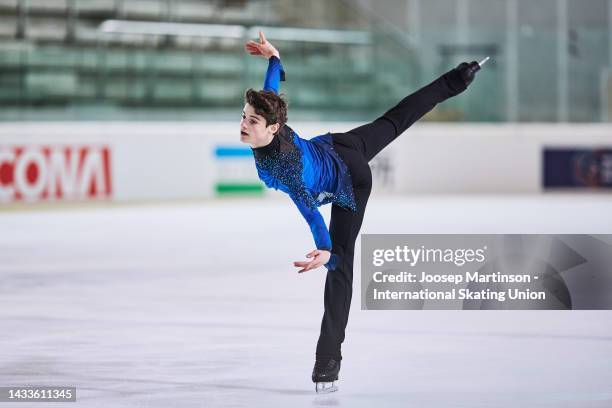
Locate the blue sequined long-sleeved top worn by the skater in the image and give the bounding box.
[252,57,357,268]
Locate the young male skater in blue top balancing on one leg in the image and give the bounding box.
[240,32,480,392]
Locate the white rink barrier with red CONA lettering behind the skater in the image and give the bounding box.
[0,121,612,203]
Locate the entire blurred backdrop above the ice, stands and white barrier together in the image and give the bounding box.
[0,0,612,203]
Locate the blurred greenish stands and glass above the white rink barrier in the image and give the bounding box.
[0,0,612,122]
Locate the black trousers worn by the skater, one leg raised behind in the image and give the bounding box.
[316,70,465,360]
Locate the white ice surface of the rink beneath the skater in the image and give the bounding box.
[0,194,612,408]
